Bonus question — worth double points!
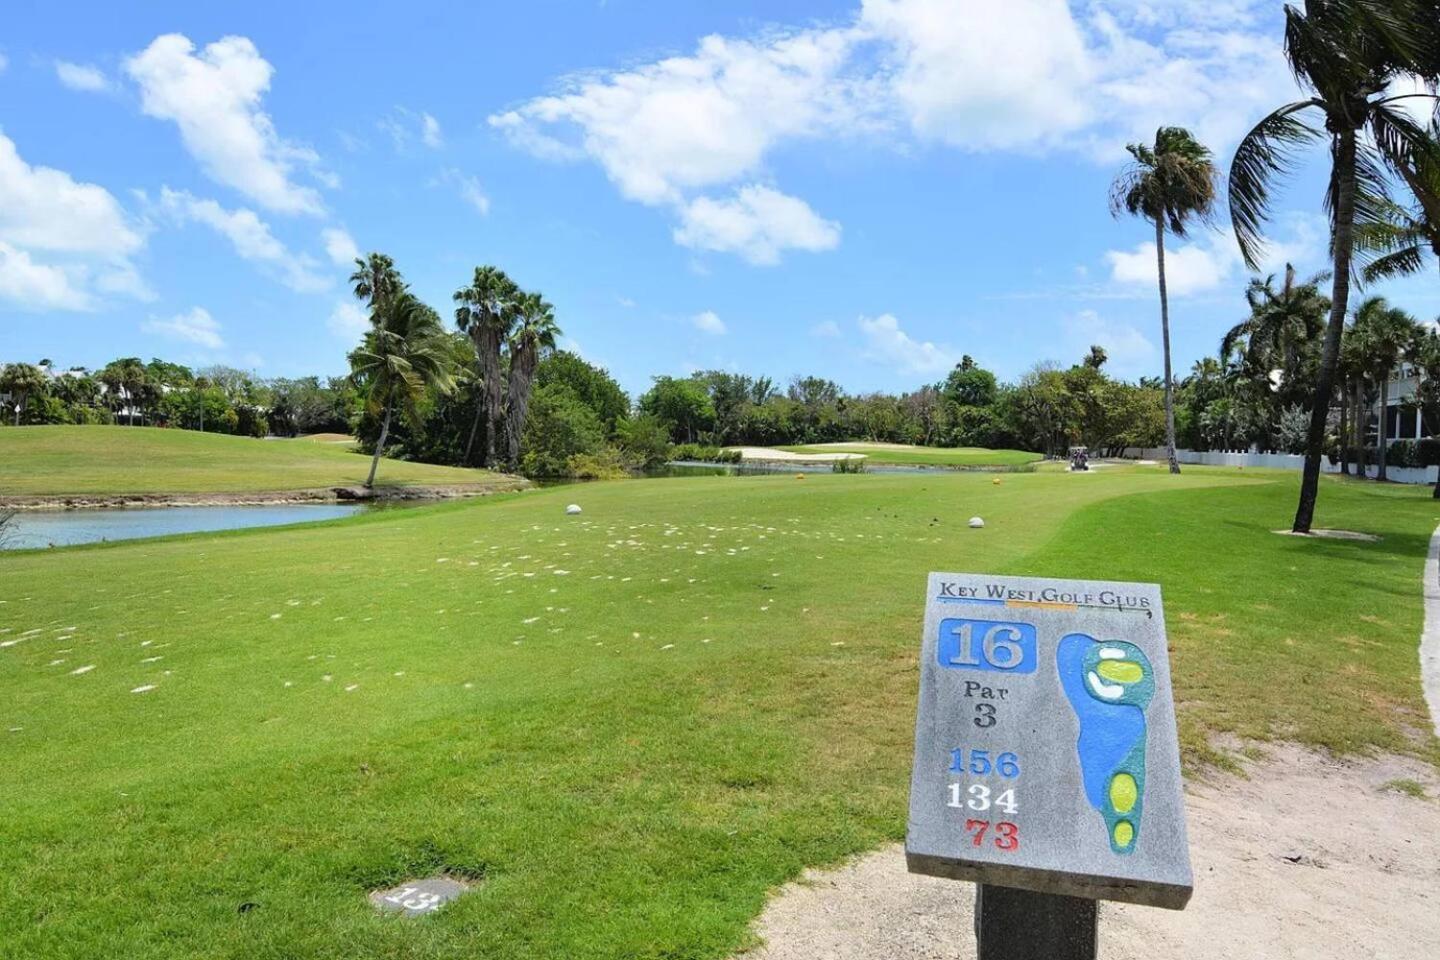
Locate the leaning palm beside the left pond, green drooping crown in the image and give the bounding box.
[350,292,455,488]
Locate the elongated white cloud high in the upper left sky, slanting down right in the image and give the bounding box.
[125,33,324,213]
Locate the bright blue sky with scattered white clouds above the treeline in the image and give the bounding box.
[0,0,1440,391]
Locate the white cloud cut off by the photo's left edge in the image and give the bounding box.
[0,134,150,309]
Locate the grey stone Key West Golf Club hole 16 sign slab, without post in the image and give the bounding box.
[906,573,1191,910]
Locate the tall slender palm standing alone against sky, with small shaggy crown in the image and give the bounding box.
[1110,127,1220,474]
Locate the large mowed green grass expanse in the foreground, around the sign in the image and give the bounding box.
[0,469,1440,960]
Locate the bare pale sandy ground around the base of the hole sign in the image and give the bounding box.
[744,746,1440,960]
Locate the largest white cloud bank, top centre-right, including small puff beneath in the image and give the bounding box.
[490,0,1295,263]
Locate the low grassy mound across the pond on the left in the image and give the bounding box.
[0,426,512,497]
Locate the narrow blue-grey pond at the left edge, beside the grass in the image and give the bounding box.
[0,504,367,550]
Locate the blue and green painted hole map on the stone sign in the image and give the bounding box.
[1056,633,1155,853]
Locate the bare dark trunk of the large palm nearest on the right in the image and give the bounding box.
[1292,128,1355,534]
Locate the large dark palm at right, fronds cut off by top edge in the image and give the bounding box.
[1230,0,1440,533]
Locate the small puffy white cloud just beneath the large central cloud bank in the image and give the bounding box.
[674,184,840,265]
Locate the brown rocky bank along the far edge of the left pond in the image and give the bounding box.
[0,476,533,510]
